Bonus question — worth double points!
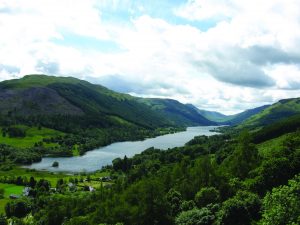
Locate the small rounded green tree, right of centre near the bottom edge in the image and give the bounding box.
[195,187,220,208]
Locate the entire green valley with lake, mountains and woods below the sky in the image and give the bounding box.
[0,75,300,225]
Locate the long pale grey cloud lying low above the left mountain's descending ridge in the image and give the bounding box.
[86,75,190,97]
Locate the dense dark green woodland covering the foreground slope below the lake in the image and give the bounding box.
[2,122,300,225]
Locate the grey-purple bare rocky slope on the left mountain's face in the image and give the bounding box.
[0,87,84,116]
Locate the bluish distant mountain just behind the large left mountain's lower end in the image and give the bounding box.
[139,98,217,126]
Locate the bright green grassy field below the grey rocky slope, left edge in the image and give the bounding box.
[0,126,64,148]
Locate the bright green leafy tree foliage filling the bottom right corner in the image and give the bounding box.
[261,176,300,225]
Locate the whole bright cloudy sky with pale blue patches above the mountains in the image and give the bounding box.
[0,0,300,114]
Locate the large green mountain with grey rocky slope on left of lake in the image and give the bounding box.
[0,75,168,128]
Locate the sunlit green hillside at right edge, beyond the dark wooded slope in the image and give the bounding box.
[240,98,300,127]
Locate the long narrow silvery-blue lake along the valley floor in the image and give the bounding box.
[24,126,216,173]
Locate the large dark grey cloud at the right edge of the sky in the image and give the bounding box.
[191,45,300,90]
